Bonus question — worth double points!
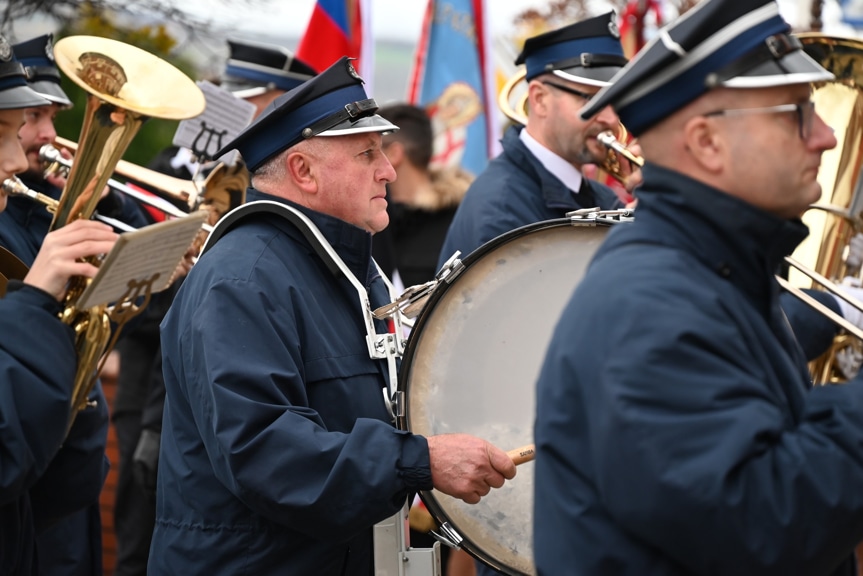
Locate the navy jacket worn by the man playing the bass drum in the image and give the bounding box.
[153,188,431,576]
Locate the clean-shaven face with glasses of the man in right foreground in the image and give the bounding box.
[711,84,836,218]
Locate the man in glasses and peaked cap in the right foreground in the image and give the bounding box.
[533,0,863,576]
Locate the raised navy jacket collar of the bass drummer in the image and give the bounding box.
[246,187,379,288]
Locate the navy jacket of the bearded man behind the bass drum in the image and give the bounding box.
[437,126,623,269]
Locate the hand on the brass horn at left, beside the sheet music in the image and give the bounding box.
[24,220,118,301]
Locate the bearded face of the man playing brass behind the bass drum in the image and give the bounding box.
[535,75,620,167]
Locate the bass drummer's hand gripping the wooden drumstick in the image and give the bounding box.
[428,434,515,504]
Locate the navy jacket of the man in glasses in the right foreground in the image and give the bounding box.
[534,165,863,576]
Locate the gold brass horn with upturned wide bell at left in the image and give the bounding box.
[50,36,205,427]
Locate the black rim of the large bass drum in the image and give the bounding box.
[398,218,616,576]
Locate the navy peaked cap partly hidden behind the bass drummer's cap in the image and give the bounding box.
[220,40,316,98]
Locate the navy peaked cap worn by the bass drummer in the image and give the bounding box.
[216,56,398,172]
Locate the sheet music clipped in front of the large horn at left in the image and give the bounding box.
[76,210,207,310]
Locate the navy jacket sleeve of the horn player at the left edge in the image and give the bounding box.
[0,282,104,575]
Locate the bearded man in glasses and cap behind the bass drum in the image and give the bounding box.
[438,12,638,267]
